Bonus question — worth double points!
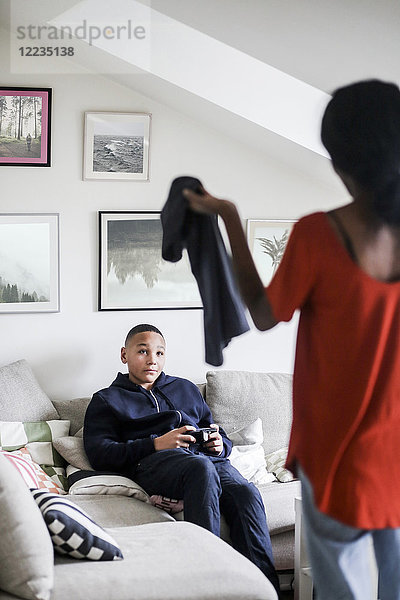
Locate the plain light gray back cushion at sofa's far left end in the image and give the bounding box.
[0,360,59,421]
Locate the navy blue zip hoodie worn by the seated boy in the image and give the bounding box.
[83,372,232,478]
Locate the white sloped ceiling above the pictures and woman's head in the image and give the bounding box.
[0,0,400,191]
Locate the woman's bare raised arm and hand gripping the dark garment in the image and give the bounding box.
[183,190,278,331]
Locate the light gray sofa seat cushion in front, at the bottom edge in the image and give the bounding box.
[52,520,277,600]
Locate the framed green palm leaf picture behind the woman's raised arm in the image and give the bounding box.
[247,219,296,286]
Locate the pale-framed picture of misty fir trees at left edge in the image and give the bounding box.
[0,213,60,313]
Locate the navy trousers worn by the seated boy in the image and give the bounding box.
[134,448,279,594]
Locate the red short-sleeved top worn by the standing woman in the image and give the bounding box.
[266,213,400,529]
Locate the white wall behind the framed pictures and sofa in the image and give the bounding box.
[0,30,342,399]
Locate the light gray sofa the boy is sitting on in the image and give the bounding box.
[0,361,300,600]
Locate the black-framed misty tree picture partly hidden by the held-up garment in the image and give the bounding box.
[99,211,202,310]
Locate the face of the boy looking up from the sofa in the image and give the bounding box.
[121,331,165,390]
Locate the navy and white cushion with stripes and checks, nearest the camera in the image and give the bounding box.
[32,490,123,560]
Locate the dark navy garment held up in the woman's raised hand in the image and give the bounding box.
[161,177,250,367]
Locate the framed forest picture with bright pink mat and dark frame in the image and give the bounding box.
[0,86,52,167]
